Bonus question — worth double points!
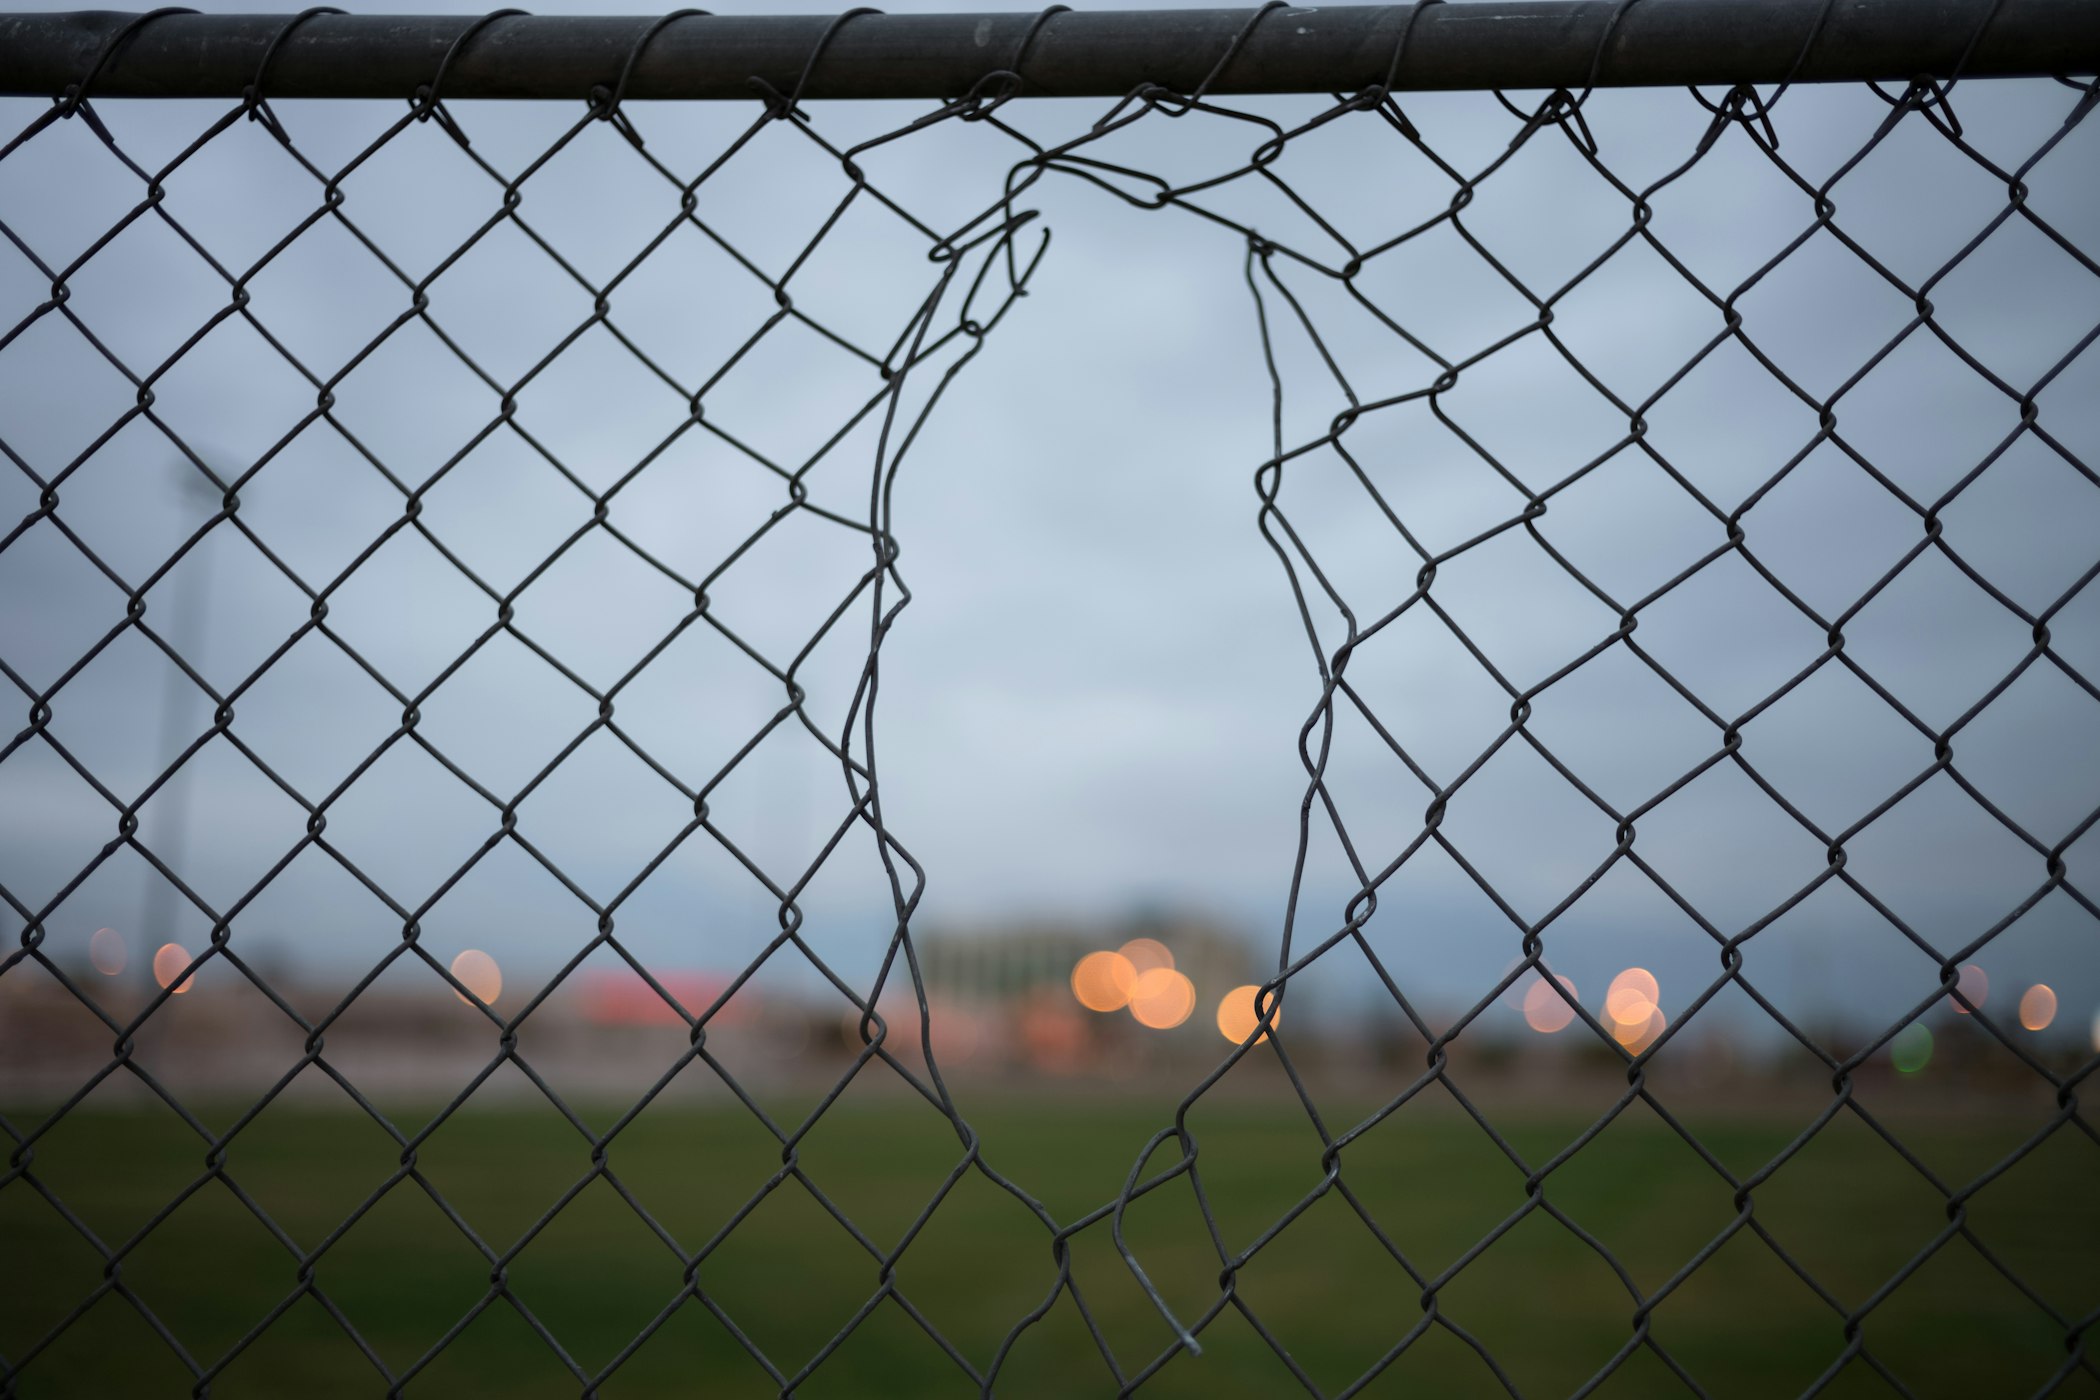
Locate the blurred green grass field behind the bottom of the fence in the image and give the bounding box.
[0,1094,2100,1400]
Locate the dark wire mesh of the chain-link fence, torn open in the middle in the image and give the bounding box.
[0,0,2100,1396]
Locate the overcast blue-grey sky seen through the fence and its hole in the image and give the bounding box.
[0,4,2100,1049]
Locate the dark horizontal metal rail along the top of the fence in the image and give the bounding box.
[0,0,2100,99]
